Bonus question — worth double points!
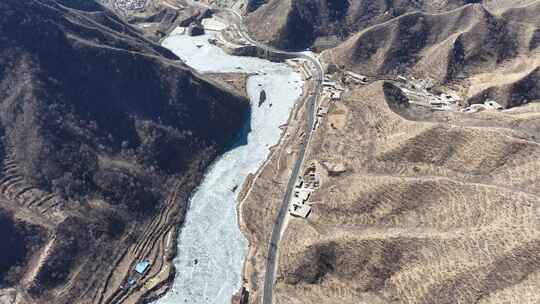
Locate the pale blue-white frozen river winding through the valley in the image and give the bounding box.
[156,31,303,304]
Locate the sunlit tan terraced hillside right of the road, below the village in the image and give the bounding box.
[275,82,540,304]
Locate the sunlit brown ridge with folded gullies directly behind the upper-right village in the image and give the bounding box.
[324,3,540,107]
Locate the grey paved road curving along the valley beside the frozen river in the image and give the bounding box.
[221,9,324,304]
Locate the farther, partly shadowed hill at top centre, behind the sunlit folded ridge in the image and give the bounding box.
[247,0,471,49]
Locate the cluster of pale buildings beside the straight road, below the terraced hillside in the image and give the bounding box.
[289,164,320,218]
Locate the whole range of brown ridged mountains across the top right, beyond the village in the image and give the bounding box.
[247,0,540,107]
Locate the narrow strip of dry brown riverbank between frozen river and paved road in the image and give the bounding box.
[238,67,313,303]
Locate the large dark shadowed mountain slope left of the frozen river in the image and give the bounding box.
[0,0,248,303]
